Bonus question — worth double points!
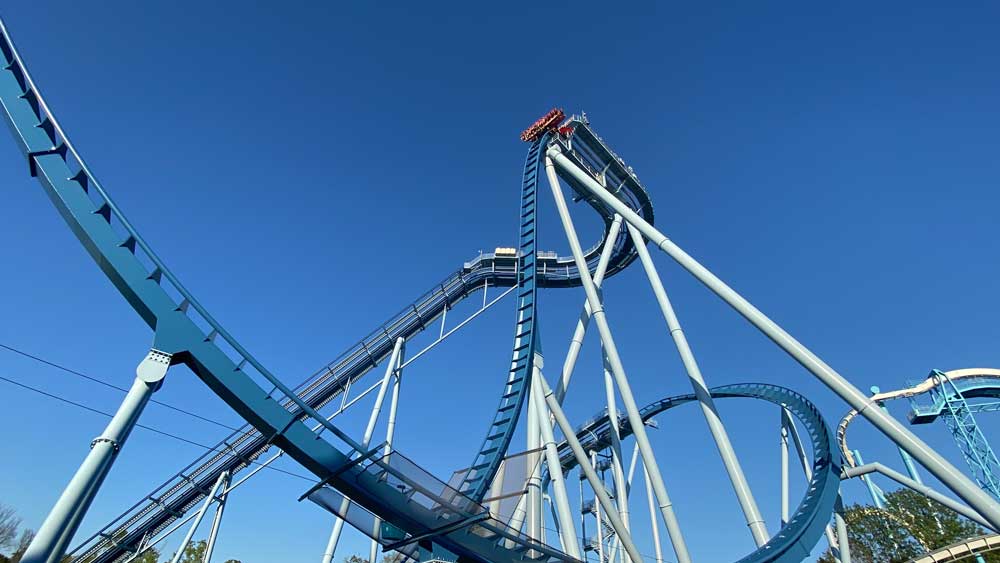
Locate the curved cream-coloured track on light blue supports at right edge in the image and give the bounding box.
[837,368,1000,467]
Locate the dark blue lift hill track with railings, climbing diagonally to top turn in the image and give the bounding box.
[54,119,652,563]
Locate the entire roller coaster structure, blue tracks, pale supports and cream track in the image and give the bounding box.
[0,12,1000,563]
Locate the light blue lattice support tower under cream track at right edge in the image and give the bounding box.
[909,370,1000,499]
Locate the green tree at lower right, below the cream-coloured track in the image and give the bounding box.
[817,489,1000,563]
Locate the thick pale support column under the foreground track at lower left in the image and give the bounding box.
[21,350,171,563]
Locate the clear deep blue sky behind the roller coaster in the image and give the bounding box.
[0,1,1000,563]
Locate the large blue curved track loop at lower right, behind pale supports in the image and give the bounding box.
[559,383,840,563]
